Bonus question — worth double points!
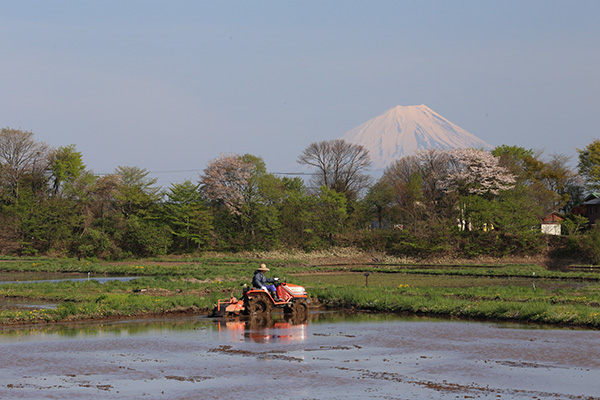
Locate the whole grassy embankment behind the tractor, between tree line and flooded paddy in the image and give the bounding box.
[0,258,600,328]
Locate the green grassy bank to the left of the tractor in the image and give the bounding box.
[0,278,241,323]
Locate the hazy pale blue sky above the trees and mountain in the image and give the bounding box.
[0,0,600,186]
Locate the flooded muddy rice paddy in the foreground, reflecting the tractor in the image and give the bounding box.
[0,313,600,399]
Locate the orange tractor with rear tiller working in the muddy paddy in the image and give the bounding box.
[211,282,308,317]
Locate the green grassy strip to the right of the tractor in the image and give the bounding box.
[300,267,600,328]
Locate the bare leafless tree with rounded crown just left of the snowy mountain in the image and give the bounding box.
[298,139,371,200]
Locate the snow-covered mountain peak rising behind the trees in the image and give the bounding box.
[342,104,492,170]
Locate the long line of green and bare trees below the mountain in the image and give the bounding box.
[0,128,600,259]
